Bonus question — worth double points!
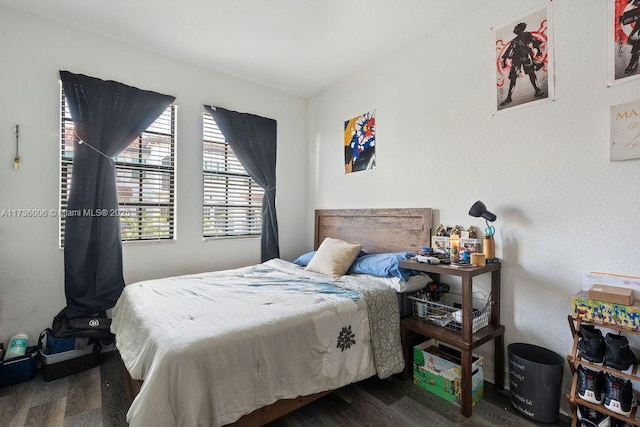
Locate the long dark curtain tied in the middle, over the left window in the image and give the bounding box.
[60,71,175,317]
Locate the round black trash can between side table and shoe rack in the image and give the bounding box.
[507,343,564,423]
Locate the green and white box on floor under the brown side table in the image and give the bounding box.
[413,340,484,406]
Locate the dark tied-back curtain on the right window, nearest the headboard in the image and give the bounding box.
[204,105,280,262]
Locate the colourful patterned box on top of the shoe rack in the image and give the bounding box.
[571,291,640,331]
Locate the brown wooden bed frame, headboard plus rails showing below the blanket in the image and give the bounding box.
[122,208,432,426]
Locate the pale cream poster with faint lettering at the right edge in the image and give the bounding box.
[609,102,640,161]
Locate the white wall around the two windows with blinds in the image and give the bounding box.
[0,7,311,345]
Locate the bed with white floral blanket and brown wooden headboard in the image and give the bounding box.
[112,208,431,426]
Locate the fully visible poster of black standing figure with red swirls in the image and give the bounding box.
[492,2,553,111]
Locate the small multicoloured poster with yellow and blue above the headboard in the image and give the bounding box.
[344,111,376,173]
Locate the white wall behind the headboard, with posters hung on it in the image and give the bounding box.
[308,0,640,392]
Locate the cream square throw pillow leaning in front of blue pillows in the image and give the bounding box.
[306,237,362,277]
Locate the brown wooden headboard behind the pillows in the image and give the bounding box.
[313,208,431,254]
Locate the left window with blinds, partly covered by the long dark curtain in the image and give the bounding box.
[60,88,176,246]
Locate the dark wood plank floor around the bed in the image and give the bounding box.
[0,351,570,427]
